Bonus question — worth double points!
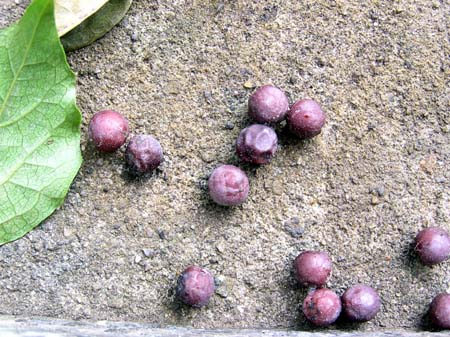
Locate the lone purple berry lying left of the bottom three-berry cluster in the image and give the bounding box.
[177,266,215,308]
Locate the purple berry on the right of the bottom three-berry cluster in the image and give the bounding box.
[342,284,381,322]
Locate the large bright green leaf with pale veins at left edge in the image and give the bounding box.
[0,0,81,244]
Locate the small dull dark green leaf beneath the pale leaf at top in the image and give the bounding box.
[61,0,132,51]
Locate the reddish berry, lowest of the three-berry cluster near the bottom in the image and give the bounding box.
[303,288,342,327]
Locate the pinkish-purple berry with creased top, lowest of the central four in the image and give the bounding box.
[208,165,249,206]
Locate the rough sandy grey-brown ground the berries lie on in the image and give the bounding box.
[0,0,450,330]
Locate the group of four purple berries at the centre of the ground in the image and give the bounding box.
[208,85,326,206]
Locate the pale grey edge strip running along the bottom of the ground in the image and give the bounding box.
[0,316,450,337]
